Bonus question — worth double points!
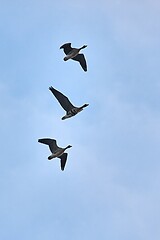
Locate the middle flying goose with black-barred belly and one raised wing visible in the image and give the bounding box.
[49,86,89,120]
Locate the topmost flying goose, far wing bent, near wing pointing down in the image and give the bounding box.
[60,43,87,72]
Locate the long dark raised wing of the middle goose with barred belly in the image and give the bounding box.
[49,86,75,112]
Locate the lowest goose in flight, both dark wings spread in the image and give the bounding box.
[38,138,72,171]
